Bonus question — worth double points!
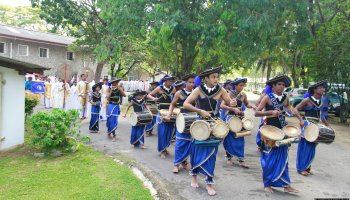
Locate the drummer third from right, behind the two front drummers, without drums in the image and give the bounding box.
[220,78,255,168]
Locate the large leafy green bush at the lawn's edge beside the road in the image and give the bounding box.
[31,109,90,154]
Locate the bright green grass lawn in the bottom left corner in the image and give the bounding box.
[0,143,152,200]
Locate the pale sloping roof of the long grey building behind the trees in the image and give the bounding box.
[0,24,75,46]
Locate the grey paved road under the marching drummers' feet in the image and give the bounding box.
[81,95,350,200]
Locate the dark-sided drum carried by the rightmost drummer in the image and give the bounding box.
[304,123,335,144]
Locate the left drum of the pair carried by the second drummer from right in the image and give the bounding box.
[260,125,284,148]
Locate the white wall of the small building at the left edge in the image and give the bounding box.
[0,66,25,151]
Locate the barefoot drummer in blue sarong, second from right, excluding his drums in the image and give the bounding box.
[255,75,304,193]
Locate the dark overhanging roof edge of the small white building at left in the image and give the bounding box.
[0,56,48,75]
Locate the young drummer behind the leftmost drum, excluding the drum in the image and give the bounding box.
[123,90,149,149]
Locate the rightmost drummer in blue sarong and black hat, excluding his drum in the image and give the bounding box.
[296,81,328,176]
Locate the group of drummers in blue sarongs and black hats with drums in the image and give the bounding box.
[89,67,335,195]
